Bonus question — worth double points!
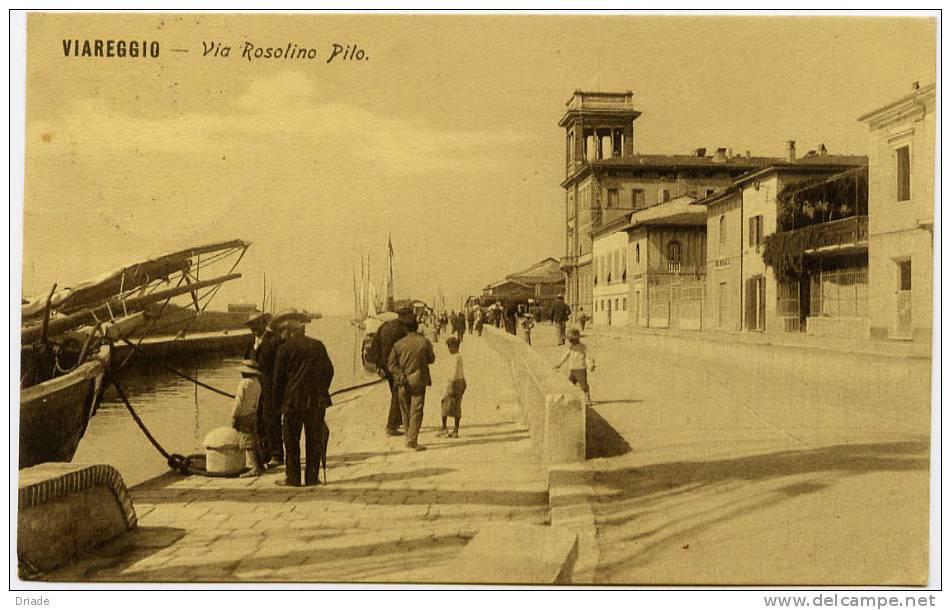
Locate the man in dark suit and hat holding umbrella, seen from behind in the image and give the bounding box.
[272,309,334,487]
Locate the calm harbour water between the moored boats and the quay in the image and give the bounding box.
[73,318,373,486]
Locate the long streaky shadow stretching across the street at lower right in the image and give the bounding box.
[592,440,930,582]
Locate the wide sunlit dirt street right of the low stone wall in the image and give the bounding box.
[534,325,931,585]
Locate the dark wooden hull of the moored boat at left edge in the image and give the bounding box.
[18,347,109,468]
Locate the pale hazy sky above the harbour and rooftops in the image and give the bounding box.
[23,13,936,315]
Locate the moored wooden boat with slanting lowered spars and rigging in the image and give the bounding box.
[18,240,250,469]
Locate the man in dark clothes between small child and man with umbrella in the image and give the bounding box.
[244,313,284,468]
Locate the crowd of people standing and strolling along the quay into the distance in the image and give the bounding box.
[231,298,595,487]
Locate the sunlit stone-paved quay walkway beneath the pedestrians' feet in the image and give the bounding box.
[46,335,548,583]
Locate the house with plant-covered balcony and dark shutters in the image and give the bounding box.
[736,141,868,338]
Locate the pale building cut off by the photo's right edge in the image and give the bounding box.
[859,83,935,342]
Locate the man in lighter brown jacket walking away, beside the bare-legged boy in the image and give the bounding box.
[387,321,436,451]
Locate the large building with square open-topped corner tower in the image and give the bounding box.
[558,90,776,316]
